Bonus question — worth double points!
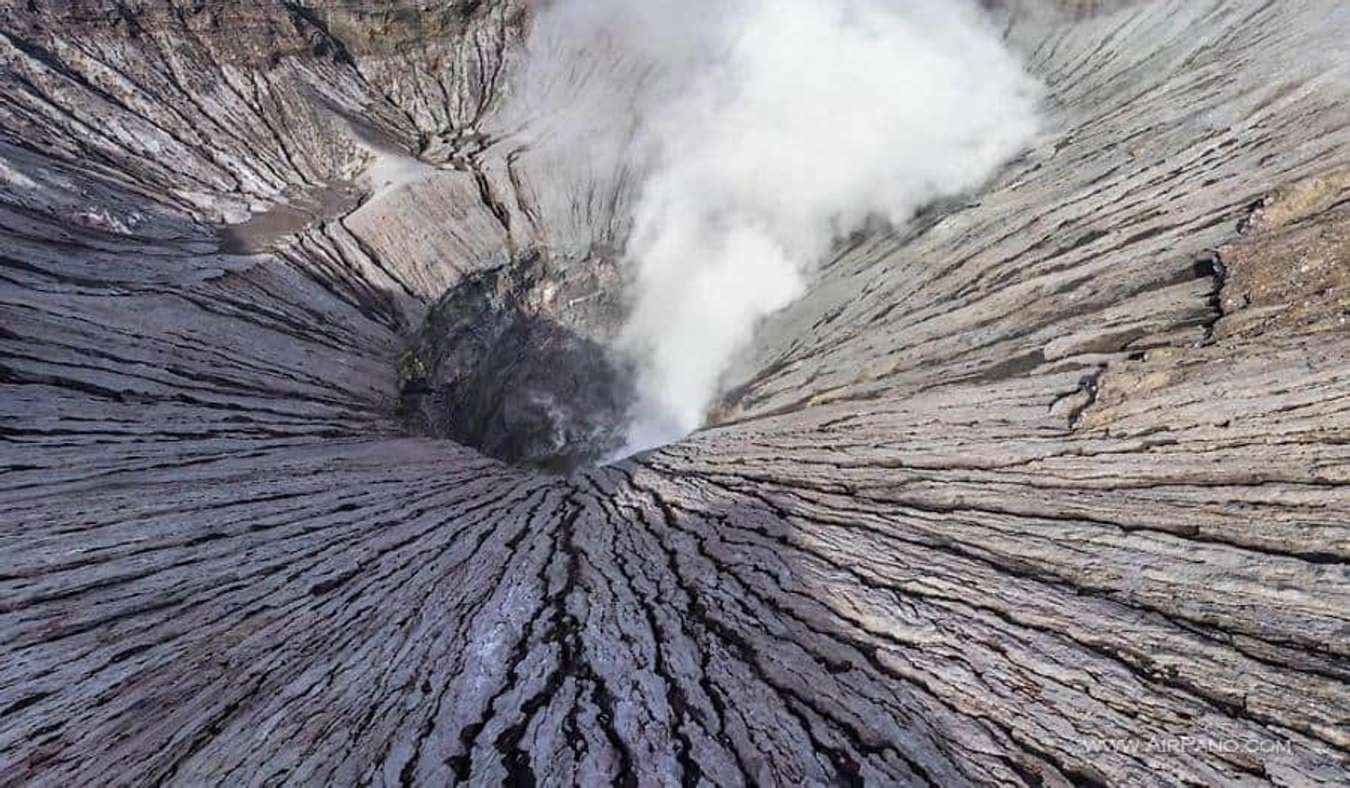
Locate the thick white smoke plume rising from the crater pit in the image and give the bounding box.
[510,0,1037,451]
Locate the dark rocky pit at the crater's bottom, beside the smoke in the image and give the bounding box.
[398,252,633,474]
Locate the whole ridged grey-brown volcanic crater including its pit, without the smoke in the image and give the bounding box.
[0,0,1350,788]
